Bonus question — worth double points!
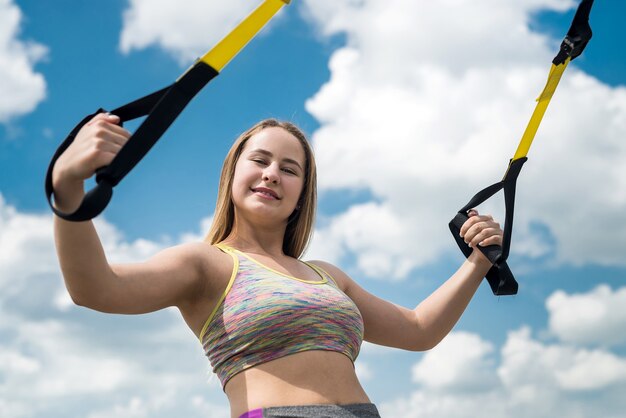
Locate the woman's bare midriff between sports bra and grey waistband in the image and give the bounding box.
[225,350,370,418]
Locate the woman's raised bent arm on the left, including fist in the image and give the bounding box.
[53,114,207,314]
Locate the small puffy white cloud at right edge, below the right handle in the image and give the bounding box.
[546,285,626,346]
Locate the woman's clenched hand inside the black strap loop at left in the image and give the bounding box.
[52,113,131,190]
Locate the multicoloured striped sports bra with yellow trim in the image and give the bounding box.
[200,244,364,388]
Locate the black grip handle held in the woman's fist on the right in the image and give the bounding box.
[448,212,518,296]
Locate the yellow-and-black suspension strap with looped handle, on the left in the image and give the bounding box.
[45,0,291,221]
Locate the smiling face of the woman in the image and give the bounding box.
[232,127,305,224]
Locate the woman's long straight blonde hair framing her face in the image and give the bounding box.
[204,119,317,258]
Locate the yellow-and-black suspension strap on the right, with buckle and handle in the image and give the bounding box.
[449,0,593,295]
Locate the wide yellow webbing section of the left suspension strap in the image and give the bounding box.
[200,0,291,72]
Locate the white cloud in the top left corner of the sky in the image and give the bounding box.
[0,0,47,123]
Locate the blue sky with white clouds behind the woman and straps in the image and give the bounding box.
[0,0,626,418]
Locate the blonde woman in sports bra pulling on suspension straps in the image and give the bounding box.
[53,114,502,418]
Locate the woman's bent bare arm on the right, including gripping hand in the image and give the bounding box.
[314,211,502,351]
